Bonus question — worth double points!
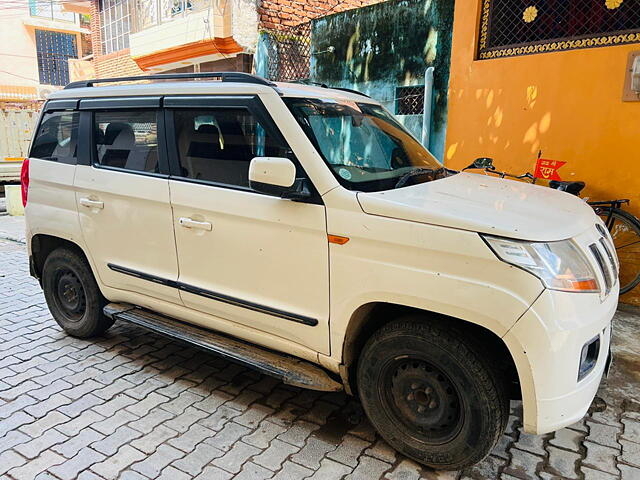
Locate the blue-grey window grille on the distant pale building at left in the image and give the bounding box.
[36,29,78,85]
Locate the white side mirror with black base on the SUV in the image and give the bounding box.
[249,157,311,200]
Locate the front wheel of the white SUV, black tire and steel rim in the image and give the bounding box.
[357,317,509,470]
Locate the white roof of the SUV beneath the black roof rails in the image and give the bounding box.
[48,80,377,103]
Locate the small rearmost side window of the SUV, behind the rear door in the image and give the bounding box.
[29,111,79,165]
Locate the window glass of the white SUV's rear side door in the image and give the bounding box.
[94,110,160,173]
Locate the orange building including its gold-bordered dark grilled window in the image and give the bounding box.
[445,0,640,304]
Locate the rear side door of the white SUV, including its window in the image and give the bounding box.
[75,97,181,303]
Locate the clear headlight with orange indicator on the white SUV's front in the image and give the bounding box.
[483,236,600,292]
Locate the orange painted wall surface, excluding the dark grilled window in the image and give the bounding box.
[445,0,640,305]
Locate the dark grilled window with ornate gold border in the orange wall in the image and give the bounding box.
[478,0,640,59]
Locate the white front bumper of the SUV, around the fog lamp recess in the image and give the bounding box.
[504,287,618,434]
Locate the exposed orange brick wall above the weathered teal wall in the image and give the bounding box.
[258,0,382,30]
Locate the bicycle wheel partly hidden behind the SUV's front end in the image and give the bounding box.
[596,207,640,294]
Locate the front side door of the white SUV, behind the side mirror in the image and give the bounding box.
[164,96,329,353]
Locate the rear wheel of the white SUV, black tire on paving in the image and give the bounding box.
[42,248,113,338]
